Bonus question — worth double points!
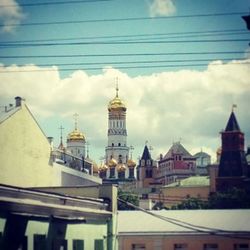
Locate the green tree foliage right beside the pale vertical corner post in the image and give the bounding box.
[118,188,139,210]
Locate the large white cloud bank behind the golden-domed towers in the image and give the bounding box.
[0,60,250,162]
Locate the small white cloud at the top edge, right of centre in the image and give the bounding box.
[149,0,176,17]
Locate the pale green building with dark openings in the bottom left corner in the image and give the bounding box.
[0,185,117,250]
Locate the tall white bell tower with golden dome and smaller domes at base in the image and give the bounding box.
[99,86,136,182]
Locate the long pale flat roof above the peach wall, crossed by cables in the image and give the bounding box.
[118,209,250,235]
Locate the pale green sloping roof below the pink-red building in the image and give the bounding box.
[164,176,210,187]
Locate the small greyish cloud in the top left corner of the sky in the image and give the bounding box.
[0,0,25,32]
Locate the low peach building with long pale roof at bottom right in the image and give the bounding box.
[118,209,250,250]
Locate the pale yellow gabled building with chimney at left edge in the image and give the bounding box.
[0,97,102,187]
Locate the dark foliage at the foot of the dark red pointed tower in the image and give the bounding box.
[208,188,250,209]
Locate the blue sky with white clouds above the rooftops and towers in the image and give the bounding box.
[0,0,250,163]
